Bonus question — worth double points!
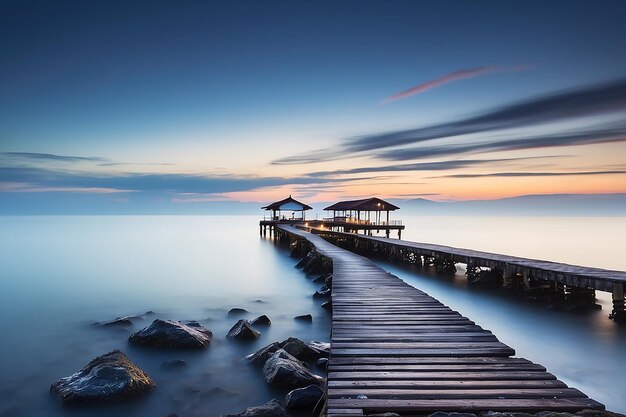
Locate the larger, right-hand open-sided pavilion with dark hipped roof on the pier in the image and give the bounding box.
[324,197,400,225]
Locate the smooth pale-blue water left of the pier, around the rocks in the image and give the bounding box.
[0,216,330,417]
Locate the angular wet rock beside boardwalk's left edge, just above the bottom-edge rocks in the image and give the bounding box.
[263,349,324,389]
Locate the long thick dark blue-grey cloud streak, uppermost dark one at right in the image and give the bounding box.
[273,78,626,164]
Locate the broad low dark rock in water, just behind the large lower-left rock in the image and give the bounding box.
[128,319,211,349]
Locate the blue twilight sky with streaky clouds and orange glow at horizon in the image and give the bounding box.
[0,0,626,211]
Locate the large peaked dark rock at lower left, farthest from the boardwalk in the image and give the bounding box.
[50,350,155,404]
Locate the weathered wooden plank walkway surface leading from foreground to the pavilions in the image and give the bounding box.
[279,226,604,417]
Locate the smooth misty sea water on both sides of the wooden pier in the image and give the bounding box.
[0,216,626,417]
